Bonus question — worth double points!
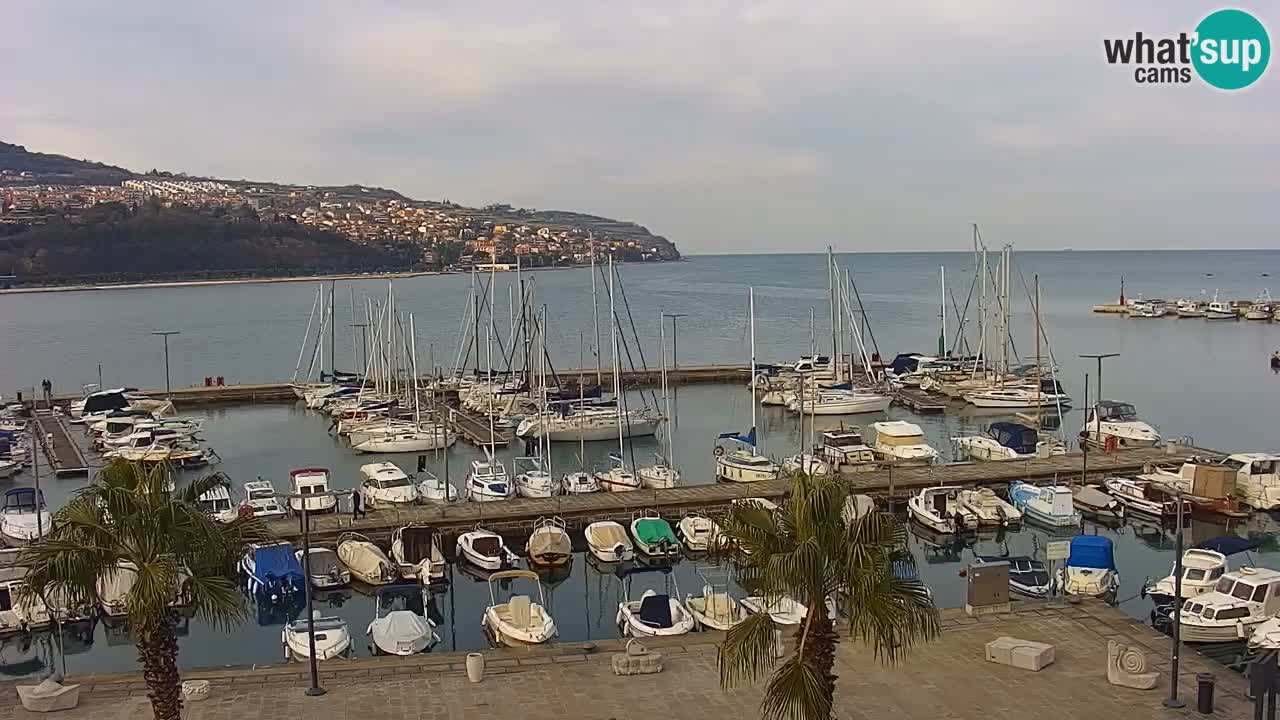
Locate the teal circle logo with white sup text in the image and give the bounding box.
[1192,10,1271,90]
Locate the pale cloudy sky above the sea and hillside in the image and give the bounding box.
[0,0,1280,254]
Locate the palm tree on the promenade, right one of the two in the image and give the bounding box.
[719,474,940,720]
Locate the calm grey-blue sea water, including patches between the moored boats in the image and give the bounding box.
[0,251,1280,675]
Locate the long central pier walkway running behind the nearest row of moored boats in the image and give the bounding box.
[268,446,1198,547]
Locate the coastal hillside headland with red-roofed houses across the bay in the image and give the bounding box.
[0,142,680,284]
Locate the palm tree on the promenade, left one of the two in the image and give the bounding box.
[22,460,265,720]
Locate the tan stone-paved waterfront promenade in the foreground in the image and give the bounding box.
[0,603,1252,720]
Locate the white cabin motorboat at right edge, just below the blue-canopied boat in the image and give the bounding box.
[1179,568,1280,643]
